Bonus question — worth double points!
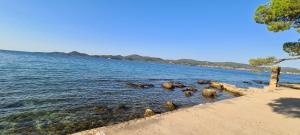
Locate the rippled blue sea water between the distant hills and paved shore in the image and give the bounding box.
[0,51,300,134]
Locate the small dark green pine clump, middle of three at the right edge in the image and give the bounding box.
[283,42,300,56]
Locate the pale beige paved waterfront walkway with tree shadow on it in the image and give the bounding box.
[74,84,300,135]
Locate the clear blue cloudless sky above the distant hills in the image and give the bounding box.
[0,0,300,68]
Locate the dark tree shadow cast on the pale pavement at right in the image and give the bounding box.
[268,98,300,118]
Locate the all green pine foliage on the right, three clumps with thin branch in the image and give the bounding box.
[249,0,300,67]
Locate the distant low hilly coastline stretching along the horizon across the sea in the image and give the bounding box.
[0,49,300,75]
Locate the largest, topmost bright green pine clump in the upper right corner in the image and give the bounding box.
[254,0,300,32]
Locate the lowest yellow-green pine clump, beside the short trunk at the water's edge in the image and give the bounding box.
[249,57,277,67]
